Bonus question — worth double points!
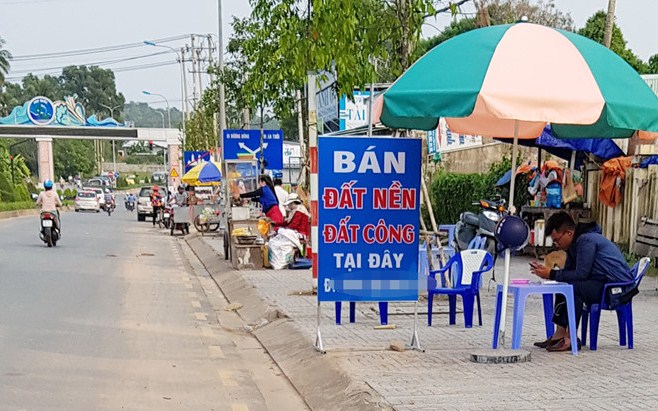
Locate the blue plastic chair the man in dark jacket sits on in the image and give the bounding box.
[581,257,651,351]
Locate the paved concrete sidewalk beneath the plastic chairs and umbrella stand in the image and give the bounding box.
[190,237,658,410]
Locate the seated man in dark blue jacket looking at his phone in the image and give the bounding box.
[531,211,633,351]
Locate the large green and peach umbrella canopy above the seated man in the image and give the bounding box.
[380,23,658,138]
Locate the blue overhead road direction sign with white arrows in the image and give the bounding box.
[223,130,283,170]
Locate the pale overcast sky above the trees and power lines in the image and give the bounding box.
[0,0,658,112]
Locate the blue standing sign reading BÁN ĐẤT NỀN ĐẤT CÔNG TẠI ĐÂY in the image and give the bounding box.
[318,137,421,301]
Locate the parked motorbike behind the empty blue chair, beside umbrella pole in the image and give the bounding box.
[453,196,507,258]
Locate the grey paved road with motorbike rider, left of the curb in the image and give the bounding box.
[0,208,306,410]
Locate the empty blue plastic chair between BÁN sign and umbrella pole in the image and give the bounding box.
[427,250,493,328]
